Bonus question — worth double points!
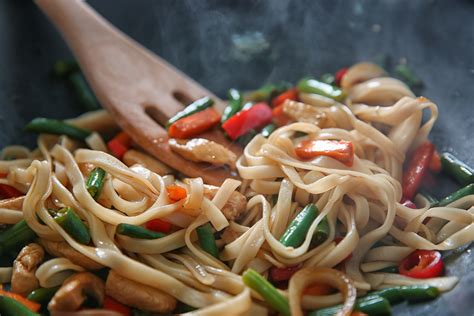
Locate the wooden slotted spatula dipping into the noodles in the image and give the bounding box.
[36,0,241,185]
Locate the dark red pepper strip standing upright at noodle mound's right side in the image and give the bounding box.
[402,142,435,200]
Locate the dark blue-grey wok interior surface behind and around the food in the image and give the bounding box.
[0,0,474,315]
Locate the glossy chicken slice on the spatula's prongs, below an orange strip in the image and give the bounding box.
[169,138,237,169]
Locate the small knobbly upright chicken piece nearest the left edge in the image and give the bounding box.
[11,243,44,296]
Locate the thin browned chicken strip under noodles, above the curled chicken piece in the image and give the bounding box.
[39,239,103,270]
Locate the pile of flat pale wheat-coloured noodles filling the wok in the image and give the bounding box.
[0,65,474,315]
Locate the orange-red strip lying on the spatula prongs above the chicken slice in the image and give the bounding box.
[168,108,221,138]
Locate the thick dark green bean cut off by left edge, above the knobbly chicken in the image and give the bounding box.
[0,219,36,257]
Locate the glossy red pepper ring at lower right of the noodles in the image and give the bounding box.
[398,250,444,279]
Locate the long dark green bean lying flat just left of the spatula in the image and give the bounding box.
[25,117,91,141]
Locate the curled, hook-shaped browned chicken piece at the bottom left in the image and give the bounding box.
[48,272,105,312]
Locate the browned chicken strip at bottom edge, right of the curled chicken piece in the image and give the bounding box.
[105,270,176,313]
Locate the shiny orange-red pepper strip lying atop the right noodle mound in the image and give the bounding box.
[295,139,354,167]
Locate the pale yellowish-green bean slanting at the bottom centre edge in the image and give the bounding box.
[242,269,291,316]
